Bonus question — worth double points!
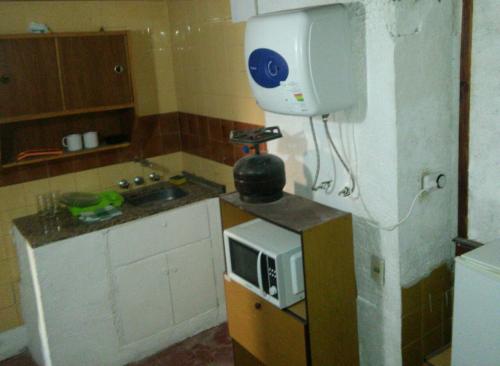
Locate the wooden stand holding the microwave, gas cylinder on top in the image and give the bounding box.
[220,192,359,366]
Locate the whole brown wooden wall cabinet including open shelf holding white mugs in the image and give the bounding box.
[0,32,136,168]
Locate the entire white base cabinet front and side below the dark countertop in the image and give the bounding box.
[14,199,226,366]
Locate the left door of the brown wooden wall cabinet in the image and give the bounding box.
[0,38,63,119]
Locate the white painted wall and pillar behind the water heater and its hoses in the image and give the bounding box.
[254,0,460,366]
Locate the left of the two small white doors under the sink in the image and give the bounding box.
[114,253,173,344]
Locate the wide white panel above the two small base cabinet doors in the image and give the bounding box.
[108,202,210,266]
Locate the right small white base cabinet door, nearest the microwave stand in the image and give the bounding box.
[167,240,217,323]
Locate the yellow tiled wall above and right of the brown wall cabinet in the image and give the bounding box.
[0,0,177,115]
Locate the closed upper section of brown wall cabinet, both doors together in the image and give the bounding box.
[0,32,134,123]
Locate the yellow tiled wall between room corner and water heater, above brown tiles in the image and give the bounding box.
[168,0,264,125]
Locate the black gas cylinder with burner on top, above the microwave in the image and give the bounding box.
[230,127,286,203]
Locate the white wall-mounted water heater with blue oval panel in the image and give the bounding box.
[245,4,354,116]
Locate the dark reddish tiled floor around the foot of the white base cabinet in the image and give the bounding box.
[0,324,233,366]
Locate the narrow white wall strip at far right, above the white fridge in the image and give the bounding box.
[469,0,500,246]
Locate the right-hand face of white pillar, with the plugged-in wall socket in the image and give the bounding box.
[393,0,461,287]
